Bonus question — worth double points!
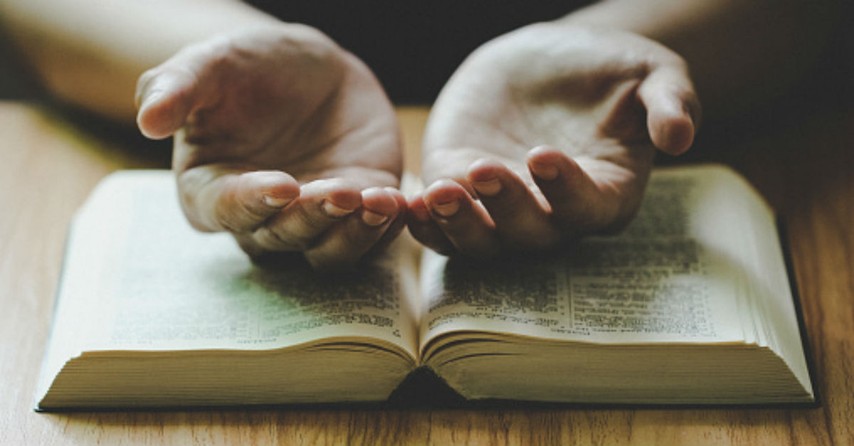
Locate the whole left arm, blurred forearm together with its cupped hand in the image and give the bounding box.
[0,0,406,269]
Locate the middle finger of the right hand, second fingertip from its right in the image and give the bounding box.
[468,160,560,249]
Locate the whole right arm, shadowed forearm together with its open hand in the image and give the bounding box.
[409,0,835,257]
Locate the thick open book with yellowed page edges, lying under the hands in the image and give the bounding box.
[37,166,814,410]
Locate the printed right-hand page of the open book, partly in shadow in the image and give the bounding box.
[421,168,750,344]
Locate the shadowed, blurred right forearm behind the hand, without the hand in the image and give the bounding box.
[562,0,839,115]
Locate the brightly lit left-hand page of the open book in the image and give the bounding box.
[46,171,416,357]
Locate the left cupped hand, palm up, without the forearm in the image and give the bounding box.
[137,24,406,268]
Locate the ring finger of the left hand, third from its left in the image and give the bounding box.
[305,187,405,270]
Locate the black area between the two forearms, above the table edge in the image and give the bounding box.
[249,0,589,104]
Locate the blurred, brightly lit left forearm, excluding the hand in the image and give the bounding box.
[0,0,274,123]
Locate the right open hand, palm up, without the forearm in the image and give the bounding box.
[409,23,699,257]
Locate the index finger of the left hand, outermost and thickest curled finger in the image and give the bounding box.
[178,164,300,232]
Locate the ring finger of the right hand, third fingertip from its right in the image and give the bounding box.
[424,180,500,258]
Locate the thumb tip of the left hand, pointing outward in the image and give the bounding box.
[136,62,198,139]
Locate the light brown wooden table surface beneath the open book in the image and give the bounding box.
[0,99,854,445]
